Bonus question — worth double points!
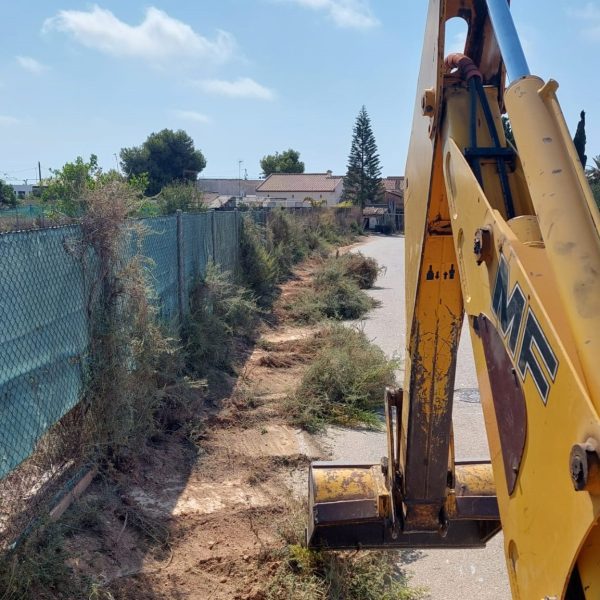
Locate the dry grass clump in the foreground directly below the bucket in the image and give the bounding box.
[264,502,423,600]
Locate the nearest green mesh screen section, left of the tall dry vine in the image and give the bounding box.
[0,227,93,477]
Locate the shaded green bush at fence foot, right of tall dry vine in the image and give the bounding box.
[182,263,258,376]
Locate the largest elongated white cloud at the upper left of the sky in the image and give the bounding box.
[43,5,236,64]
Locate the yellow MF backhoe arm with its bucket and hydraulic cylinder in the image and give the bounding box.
[308,0,600,600]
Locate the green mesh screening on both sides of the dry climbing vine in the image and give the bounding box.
[0,212,247,479]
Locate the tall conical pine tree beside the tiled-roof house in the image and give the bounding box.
[343,106,384,207]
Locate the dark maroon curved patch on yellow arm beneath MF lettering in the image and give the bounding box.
[477,315,527,494]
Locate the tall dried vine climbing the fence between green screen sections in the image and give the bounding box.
[78,182,178,464]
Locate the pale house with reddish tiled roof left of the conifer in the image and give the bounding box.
[256,171,344,207]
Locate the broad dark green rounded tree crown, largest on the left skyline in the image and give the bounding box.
[120,129,206,196]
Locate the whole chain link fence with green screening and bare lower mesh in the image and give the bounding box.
[0,209,360,546]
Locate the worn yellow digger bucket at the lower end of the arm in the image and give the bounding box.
[307,389,500,550]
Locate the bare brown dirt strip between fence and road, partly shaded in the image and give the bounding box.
[71,329,323,600]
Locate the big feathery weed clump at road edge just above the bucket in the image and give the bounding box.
[285,325,397,431]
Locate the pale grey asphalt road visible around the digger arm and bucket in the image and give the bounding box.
[328,236,510,600]
